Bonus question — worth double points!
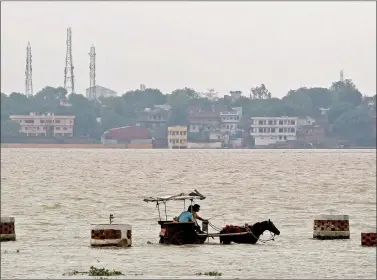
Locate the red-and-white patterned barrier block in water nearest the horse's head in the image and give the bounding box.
[313,215,350,239]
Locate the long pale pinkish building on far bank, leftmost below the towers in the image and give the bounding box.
[10,112,75,137]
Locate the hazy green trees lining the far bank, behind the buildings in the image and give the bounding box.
[1,79,376,146]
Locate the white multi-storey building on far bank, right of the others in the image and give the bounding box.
[250,117,298,146]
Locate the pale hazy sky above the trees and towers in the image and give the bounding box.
[1,2,376,97]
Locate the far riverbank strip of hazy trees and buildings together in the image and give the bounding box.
[1,80,376,149]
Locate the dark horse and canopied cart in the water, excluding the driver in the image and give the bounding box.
[144,190,280,245]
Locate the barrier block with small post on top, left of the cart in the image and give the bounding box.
[90,224,132,247]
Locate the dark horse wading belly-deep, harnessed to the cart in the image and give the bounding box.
[220,220,280,244]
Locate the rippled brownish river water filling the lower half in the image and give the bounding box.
[1,149,376,279]
